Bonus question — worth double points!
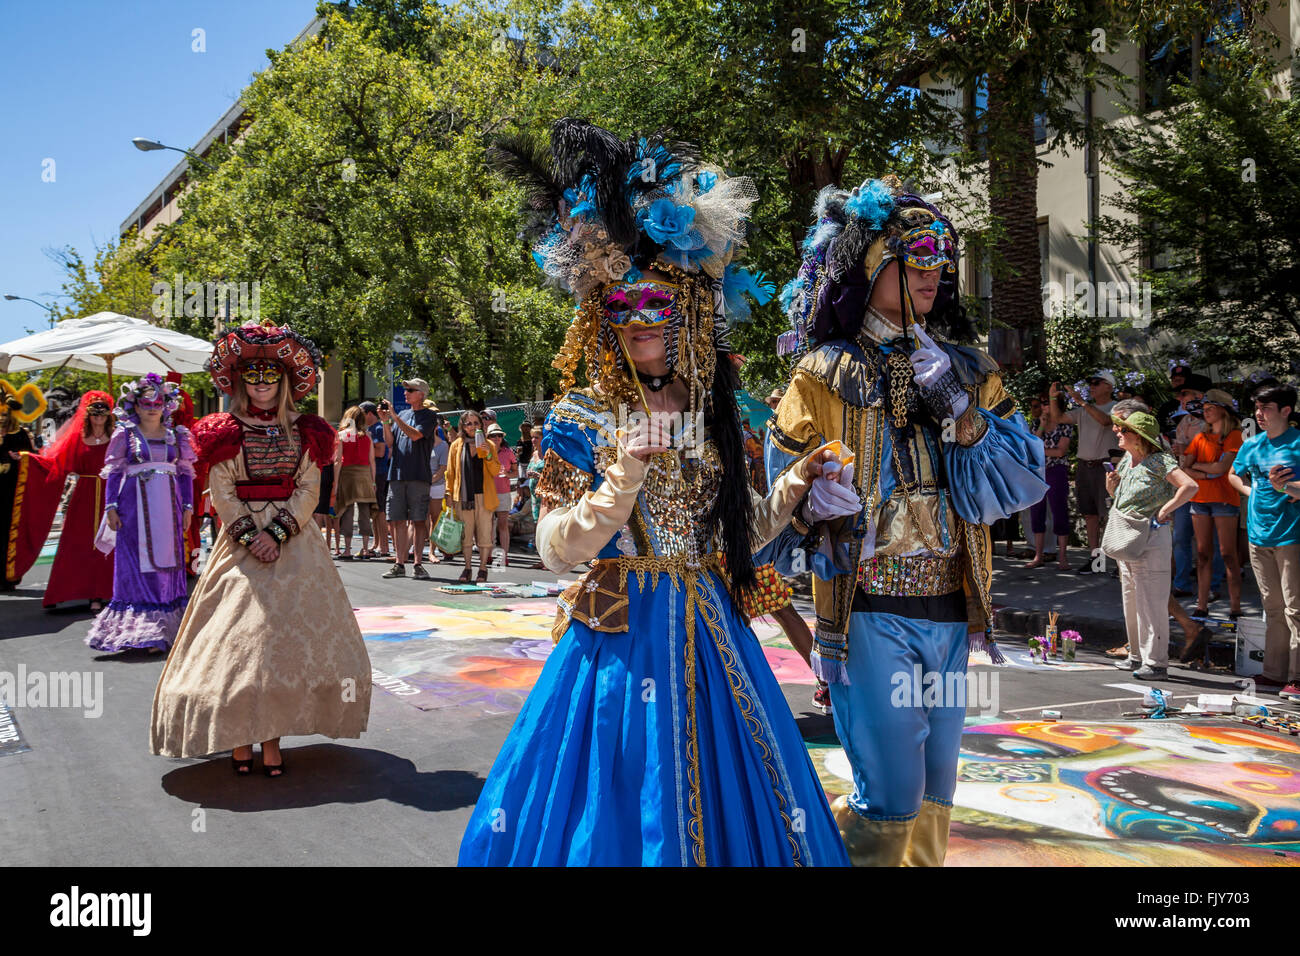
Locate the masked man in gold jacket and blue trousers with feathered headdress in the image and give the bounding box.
[762,177,1047,866]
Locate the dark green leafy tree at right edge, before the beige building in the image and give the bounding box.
[1104,49,1300,372]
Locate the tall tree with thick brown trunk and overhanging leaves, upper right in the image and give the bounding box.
[888,0,1255,364]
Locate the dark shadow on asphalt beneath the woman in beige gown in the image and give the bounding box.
[163,744,484,813]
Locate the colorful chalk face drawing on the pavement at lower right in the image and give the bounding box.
[810,719,1300,866]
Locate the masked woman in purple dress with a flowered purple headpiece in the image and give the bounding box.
[86,373,195,653]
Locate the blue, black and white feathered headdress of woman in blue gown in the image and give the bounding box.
[489,118,775,397]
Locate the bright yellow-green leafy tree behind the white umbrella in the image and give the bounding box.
[163,7,574,405]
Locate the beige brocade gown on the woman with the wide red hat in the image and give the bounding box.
[151,429,371,757]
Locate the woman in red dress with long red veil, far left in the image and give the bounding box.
[23,392,113,611]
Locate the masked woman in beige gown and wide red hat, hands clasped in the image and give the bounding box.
[151,325,371,777]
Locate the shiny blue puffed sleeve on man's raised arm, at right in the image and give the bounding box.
[944,408,1048,524]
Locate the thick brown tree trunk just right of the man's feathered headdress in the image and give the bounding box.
[987,69,1047,365]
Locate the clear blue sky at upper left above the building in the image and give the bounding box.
[0,0,316,342]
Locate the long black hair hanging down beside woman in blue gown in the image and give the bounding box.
[705,350,755,597]
